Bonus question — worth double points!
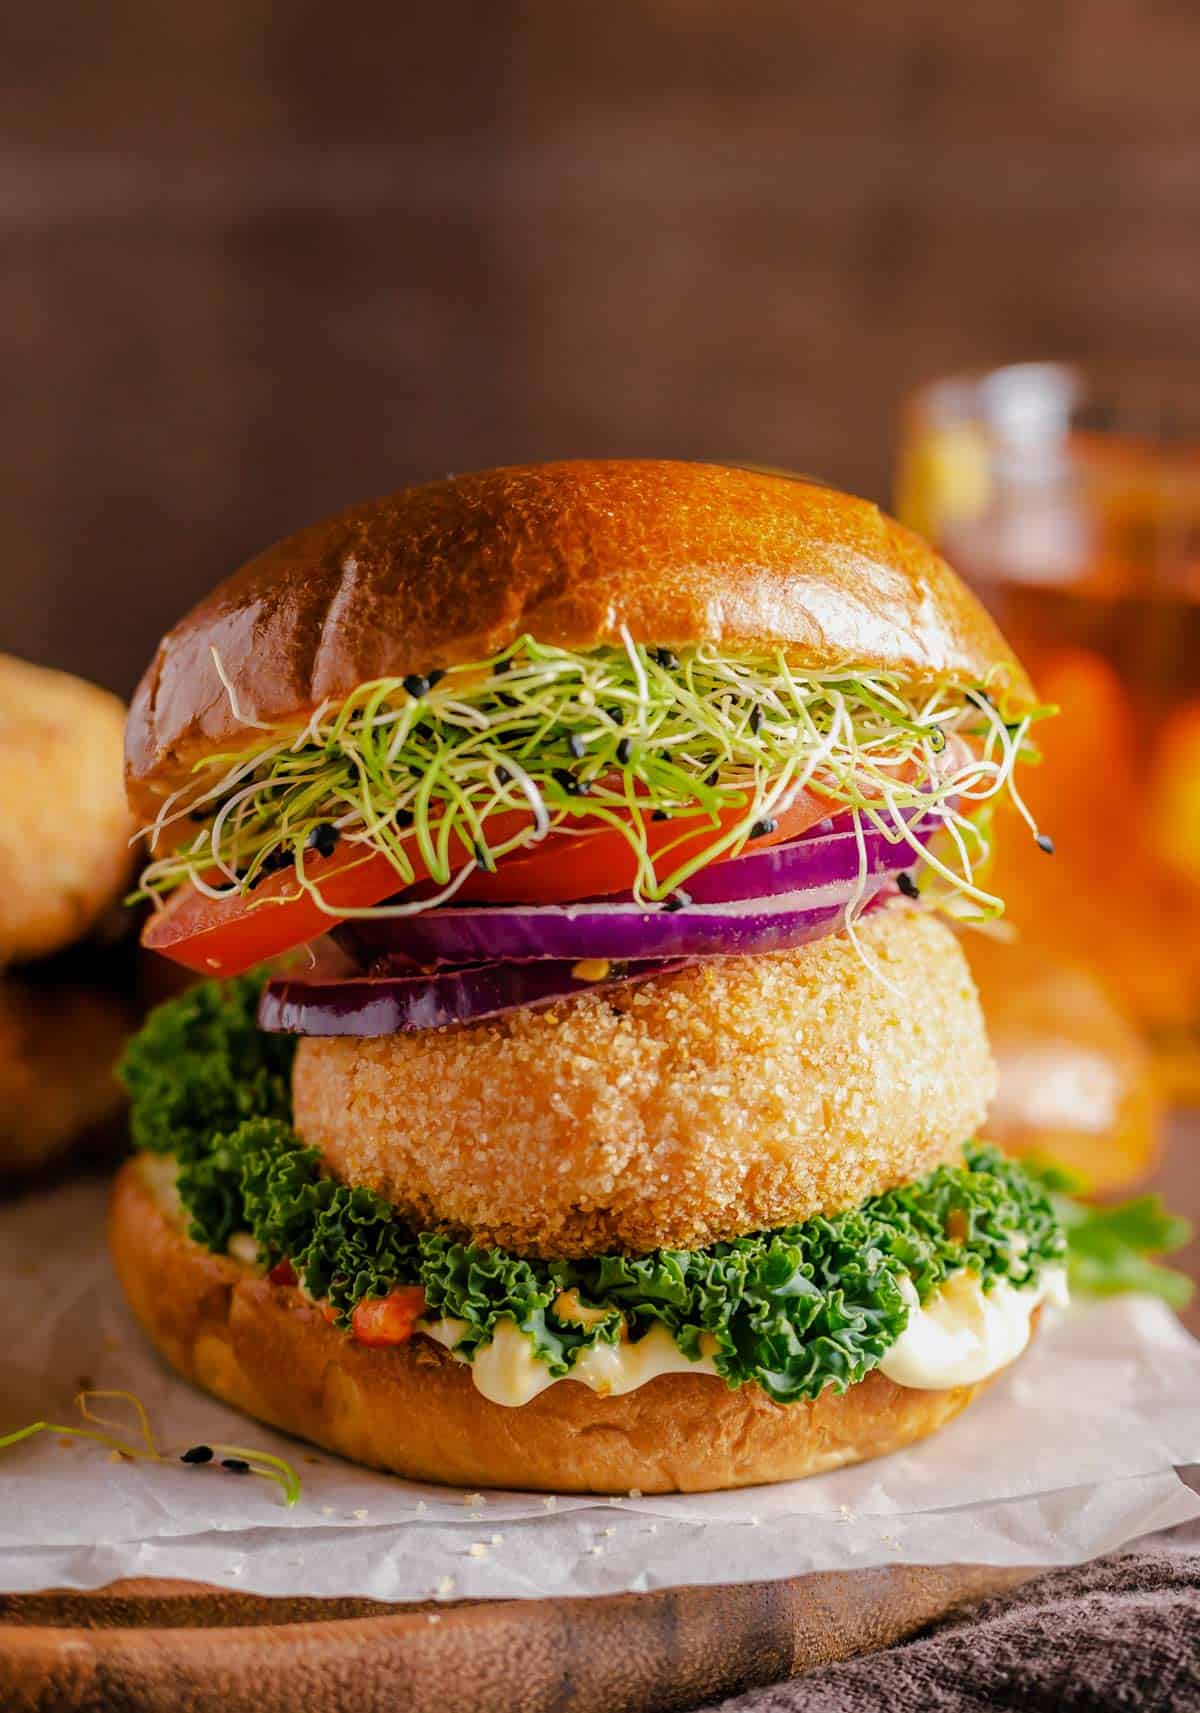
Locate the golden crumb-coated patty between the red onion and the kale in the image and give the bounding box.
[294,906,993,1257]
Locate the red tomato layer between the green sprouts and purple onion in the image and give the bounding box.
[142,791,835,976]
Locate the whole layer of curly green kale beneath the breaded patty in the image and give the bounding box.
[123,980,1065,1403]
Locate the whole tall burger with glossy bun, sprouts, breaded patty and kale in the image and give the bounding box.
[111,461,1065,1492]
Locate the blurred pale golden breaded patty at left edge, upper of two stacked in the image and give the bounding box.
[0,654,132,968]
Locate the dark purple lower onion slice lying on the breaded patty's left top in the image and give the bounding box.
[258,959,683,1035]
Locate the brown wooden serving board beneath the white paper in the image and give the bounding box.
[0,1566,1034,1713]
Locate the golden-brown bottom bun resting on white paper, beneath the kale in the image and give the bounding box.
[110,1160,1013,1494]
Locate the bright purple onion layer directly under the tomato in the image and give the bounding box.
[344,821,936,968]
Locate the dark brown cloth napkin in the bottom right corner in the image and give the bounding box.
[709,1549,1200,1713]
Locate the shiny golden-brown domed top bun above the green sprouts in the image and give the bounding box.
[125,459,1031,819]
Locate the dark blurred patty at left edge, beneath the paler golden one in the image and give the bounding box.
[0,976,130,1177]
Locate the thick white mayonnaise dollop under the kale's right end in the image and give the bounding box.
[880,1268,1066,1391]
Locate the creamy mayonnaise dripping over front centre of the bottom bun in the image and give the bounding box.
[418,1319,717,1408]
